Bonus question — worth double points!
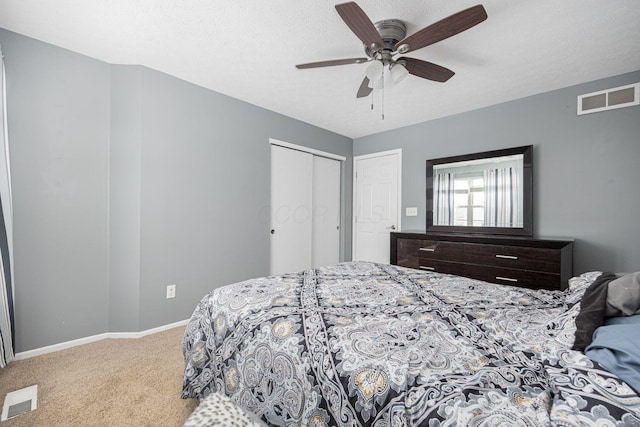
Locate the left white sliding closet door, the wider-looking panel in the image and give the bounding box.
[271,145,313,275]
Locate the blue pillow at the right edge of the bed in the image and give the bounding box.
[585,314,640,394]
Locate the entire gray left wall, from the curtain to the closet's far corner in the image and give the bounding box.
[0,29,352,352]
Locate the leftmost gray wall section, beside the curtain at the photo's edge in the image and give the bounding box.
[0,30,110,352]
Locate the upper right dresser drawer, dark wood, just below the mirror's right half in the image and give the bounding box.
[464,243,561,274]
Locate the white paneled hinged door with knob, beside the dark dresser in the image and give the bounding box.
[352,150,402,264]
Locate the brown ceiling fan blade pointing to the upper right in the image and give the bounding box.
[395,4,487,53]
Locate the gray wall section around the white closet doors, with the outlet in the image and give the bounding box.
[140,68,352,329]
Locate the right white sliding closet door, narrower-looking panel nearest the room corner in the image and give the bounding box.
[311,156,340,268]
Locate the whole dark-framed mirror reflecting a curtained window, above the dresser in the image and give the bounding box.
[426,145,533,236]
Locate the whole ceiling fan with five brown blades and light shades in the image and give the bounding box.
[296,2,487,98]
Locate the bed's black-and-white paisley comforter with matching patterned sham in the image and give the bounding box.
[182,262,640,427]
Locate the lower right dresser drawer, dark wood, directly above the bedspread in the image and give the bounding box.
[465,265,562,290]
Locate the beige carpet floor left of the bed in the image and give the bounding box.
[0,327,198,427]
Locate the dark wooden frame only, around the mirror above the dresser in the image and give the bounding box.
[426,145,533,237]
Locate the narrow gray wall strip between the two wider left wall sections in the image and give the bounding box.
[108,65,142,332]
